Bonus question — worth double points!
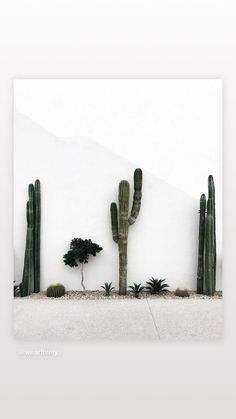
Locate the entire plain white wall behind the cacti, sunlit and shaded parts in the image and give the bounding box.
[14,80,222,289]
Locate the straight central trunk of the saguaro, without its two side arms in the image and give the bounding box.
[119,180,130,295]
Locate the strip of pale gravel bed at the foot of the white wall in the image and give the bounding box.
[15,290,222,300]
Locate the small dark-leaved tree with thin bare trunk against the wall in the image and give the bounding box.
[63,238,103,291]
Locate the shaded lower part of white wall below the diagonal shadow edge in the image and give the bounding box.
[14,83,221,289]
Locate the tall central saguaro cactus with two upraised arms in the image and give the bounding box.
[110,169,142,295]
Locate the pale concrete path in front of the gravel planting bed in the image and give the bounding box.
[14,298,223,341]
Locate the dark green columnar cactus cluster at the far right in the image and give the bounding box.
[197,175,216,296]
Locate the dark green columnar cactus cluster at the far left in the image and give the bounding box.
[20,180,41,297]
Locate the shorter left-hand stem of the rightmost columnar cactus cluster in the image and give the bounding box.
[197,194,206,294]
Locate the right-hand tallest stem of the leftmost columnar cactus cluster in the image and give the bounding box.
[34,179,41,293]
